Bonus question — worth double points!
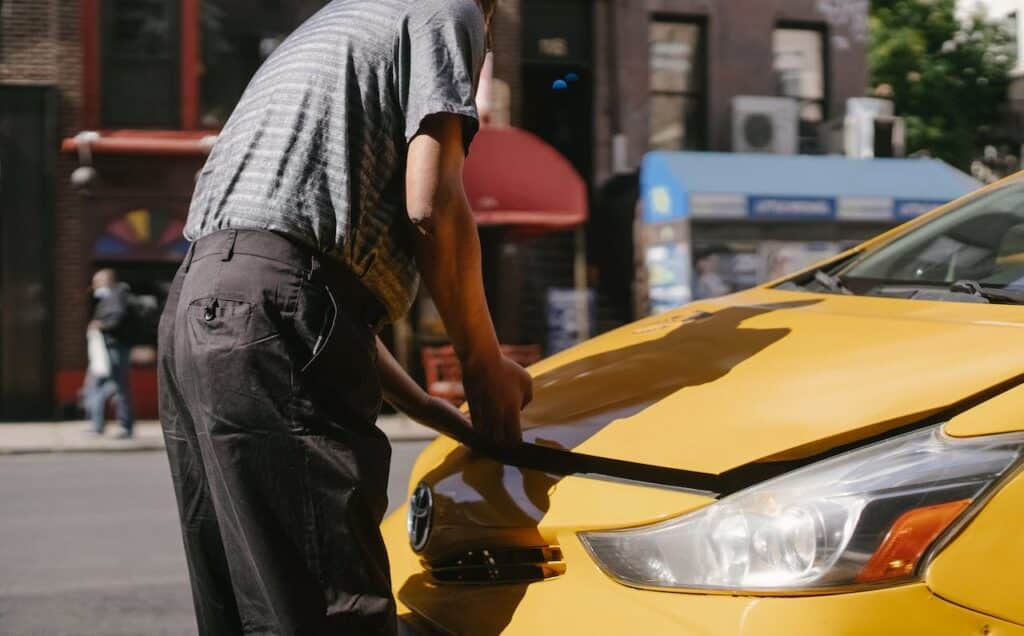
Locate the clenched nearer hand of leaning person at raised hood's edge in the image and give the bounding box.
[462,355,534,446]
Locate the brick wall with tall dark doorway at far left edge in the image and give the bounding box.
[0,0,81,417]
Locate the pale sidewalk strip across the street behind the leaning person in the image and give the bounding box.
[0,415,436,456]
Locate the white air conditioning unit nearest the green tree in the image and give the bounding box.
[843,97,906,159]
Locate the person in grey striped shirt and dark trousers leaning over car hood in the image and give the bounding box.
[160,0,530,634]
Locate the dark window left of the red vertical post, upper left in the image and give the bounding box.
[100,0,181,128]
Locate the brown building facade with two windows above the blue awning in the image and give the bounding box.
[496,0,868,184]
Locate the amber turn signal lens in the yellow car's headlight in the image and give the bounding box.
[857,499,971,583]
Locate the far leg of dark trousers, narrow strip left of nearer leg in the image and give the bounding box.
[158,271,243,636]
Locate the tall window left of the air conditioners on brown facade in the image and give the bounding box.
[648,20,705,151]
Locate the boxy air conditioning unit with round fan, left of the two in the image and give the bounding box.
[732,95,800,155]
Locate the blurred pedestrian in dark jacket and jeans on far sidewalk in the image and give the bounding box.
[85,269,135,438]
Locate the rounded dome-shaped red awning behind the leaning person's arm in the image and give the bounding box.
[464,128,587,230]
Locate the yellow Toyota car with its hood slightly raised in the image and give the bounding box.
[384,179,1024,636]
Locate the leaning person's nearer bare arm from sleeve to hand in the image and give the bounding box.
[406,115,532,443]
